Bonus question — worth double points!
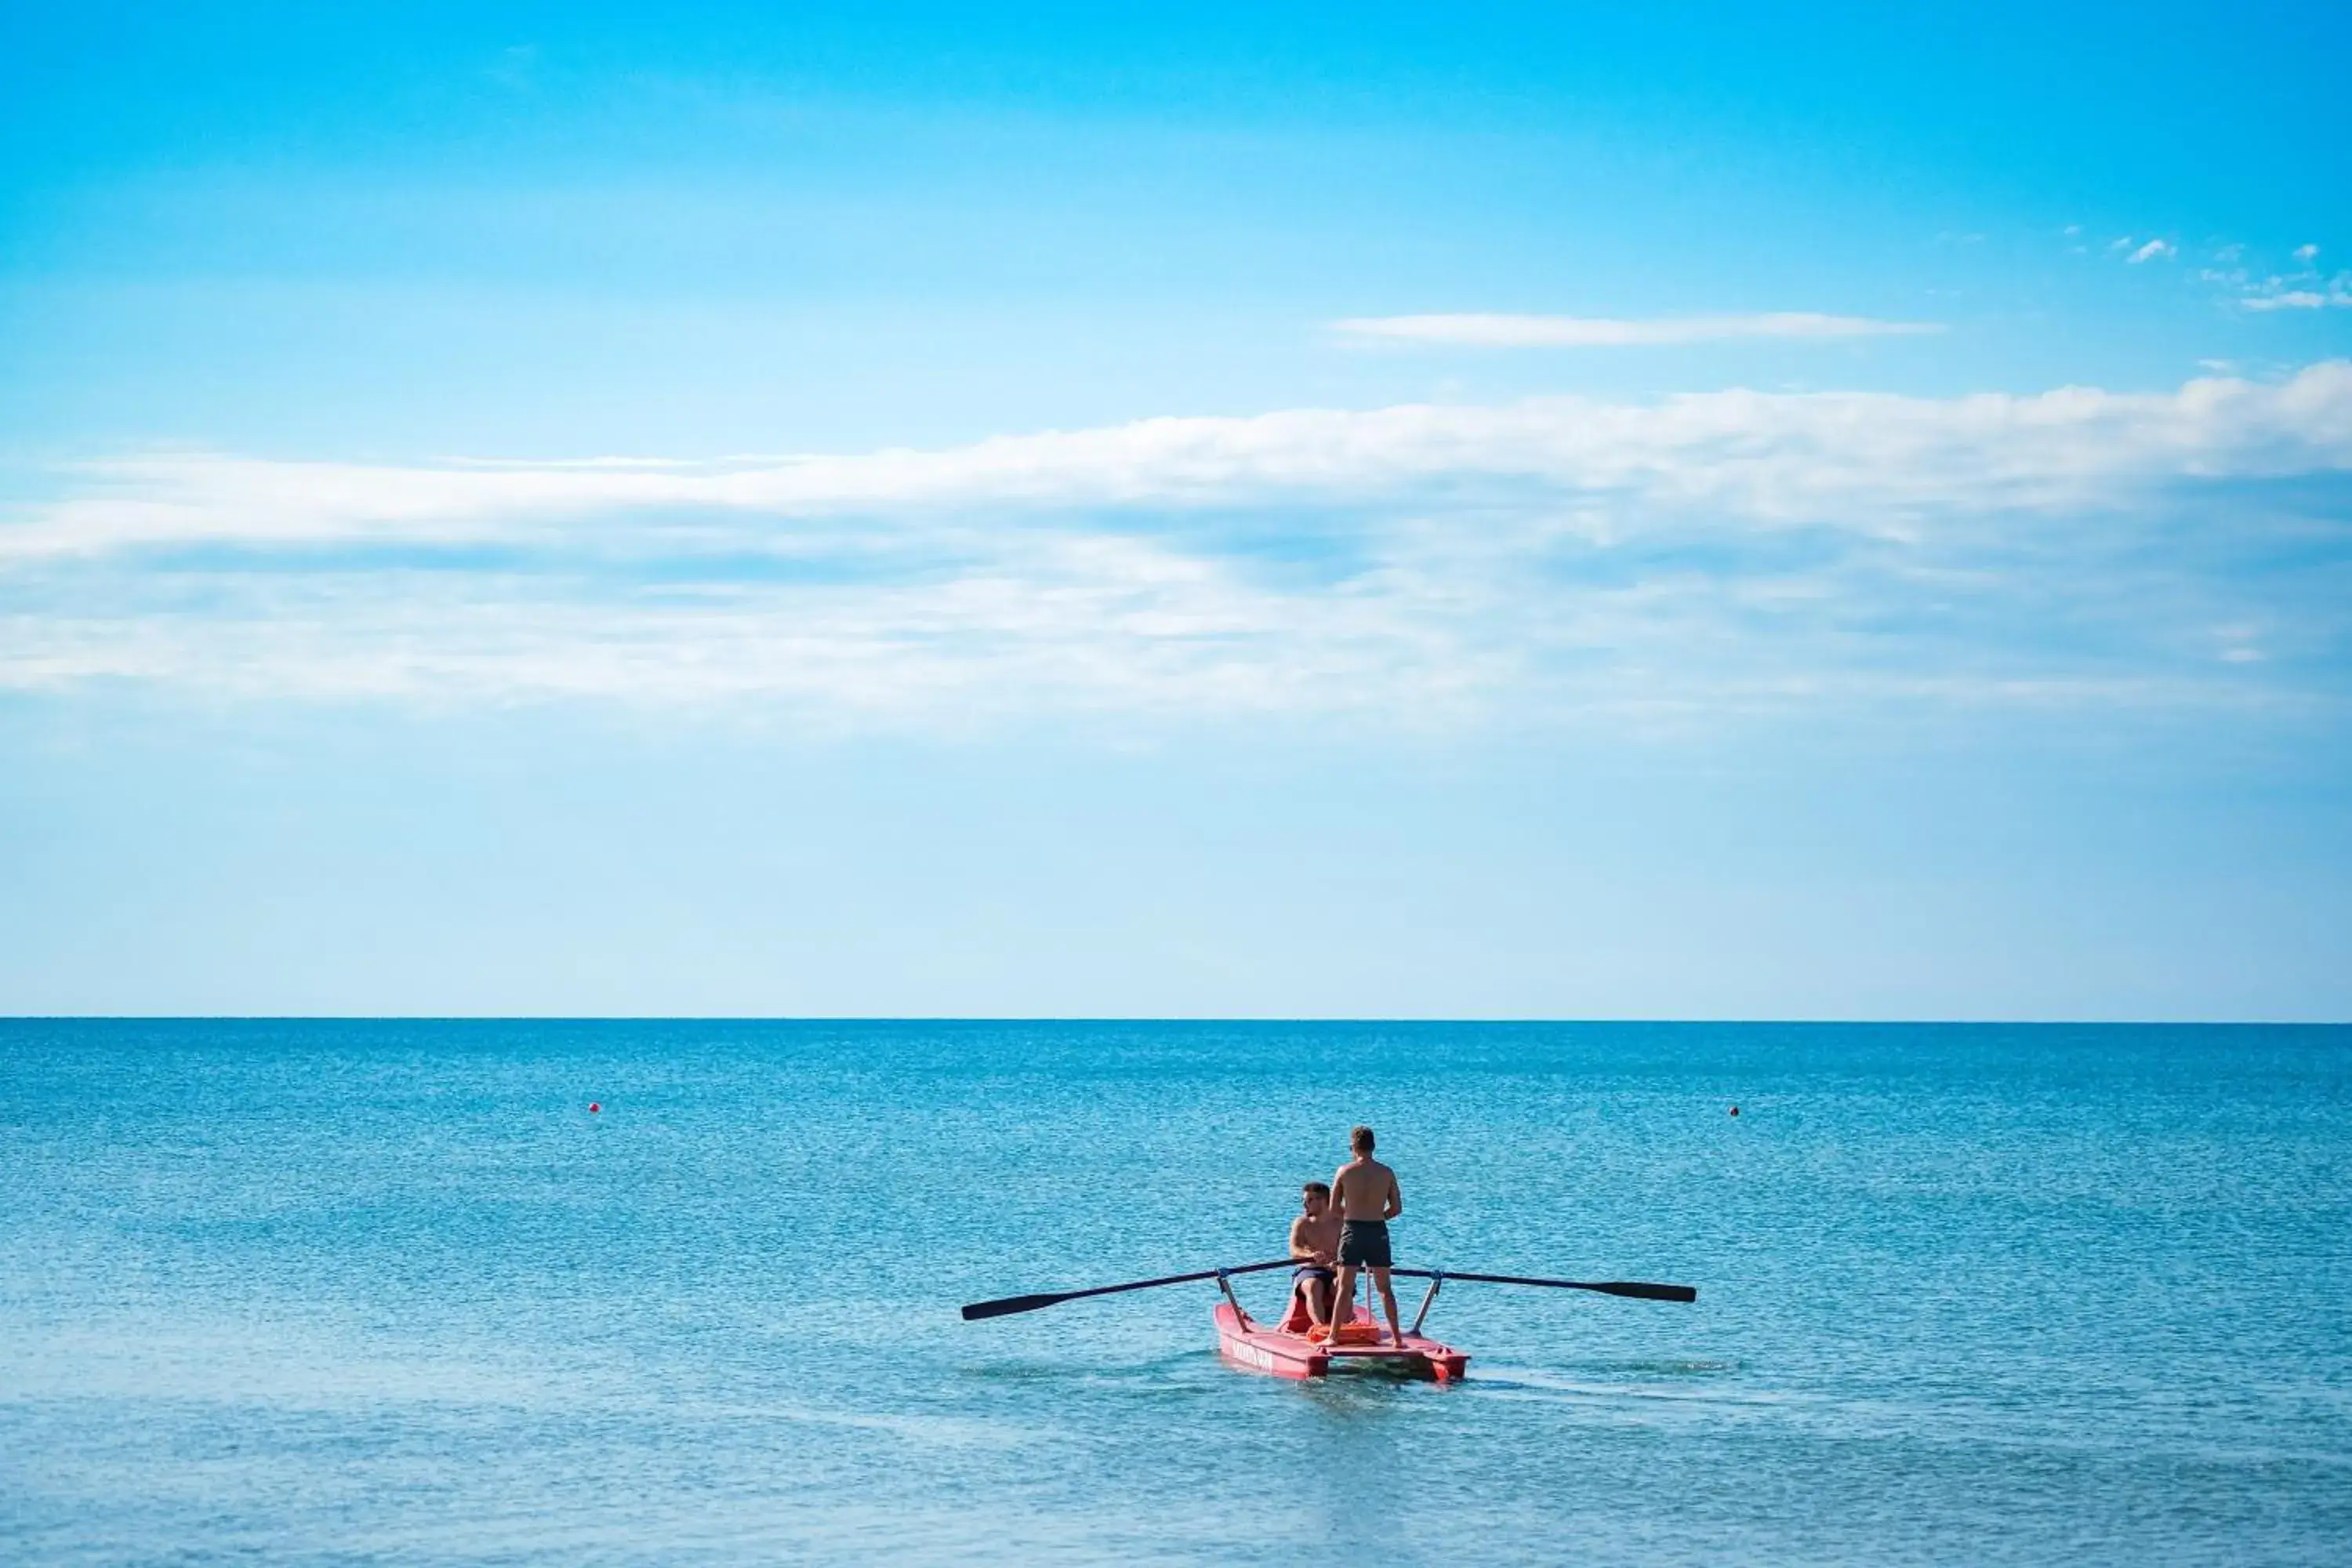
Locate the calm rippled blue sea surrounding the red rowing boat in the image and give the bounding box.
[0,1020,2352,1566]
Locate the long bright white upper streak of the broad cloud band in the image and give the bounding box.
[23,360,2352,560]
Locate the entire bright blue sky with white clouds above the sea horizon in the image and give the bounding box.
[0,0,2352,1020]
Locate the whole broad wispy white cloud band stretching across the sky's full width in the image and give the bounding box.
[0,362,2352,724]
